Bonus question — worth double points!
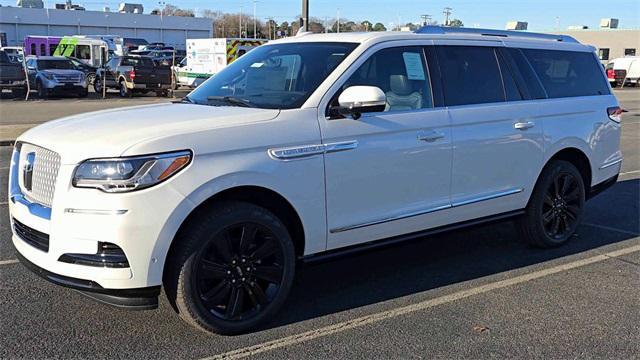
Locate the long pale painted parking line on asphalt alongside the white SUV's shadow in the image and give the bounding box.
[203,245,640,360]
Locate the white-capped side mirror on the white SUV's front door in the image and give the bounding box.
[332,86,387,120]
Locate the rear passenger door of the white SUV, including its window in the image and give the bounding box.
[437,41,543,217]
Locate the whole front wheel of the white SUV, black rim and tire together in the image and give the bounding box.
[164,202,296,335]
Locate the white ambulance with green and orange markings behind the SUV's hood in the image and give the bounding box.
[176,38,267,87]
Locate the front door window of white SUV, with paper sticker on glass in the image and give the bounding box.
[343,47,433,111]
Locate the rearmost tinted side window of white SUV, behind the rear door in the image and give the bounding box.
[522,49,609,98]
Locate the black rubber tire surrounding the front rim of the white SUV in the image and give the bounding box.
[169,202,295,335]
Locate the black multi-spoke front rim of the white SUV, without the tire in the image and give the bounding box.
[192,223,284,321]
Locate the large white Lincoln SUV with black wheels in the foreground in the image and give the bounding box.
[9,27,624,334]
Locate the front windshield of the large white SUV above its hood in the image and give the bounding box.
[187,43,358,109]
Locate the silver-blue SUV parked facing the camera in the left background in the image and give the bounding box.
[27,56,88,99]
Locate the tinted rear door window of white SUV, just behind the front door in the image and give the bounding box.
[438,46,505,106]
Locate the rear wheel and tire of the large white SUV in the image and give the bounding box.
[517,160,585,248]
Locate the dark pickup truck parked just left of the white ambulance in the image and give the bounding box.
[94,55,171,97]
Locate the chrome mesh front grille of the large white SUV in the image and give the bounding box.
[23,144,60,207]
